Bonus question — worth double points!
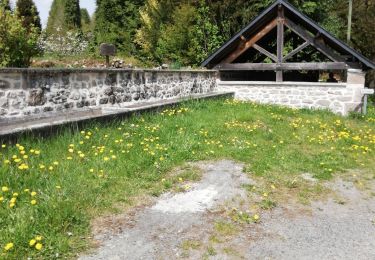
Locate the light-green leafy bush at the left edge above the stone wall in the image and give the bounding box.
[0,7,39,67]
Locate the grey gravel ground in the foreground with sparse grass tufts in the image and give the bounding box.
[81,161,375,259]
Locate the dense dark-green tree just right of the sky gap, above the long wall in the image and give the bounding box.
[94,0,144,55]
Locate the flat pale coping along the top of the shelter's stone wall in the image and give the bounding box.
[217,80,347,88]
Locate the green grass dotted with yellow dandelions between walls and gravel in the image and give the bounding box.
[0,100,375,259]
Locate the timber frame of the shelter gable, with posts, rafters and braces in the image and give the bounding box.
[202,0,375,82]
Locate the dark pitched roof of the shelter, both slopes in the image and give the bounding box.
[202,0,375,70]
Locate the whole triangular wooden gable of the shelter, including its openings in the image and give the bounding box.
[202,0,375,82]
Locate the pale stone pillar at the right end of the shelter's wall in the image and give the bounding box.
[344,69,366,114]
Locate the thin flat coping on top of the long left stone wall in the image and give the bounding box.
[0,68,217,74]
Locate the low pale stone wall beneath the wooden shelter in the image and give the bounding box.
[218,81,364,115]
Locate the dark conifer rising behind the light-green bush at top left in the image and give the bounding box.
[16,0,42,31]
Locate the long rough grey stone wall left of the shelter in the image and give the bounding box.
[0,69,217,120]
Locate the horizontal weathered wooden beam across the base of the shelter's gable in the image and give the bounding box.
[215,62,348,71]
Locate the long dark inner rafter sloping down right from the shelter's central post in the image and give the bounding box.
[285,18,345,62]
